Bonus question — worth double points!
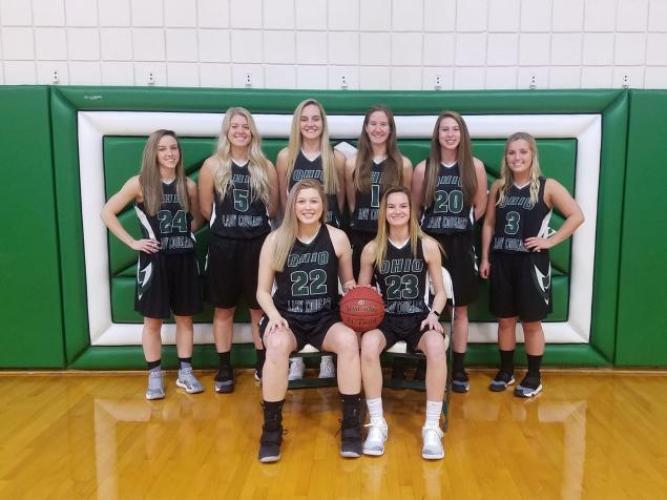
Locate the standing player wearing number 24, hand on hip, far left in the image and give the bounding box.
[102,130,204,399]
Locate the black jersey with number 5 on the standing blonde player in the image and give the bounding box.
[209,162,271,239]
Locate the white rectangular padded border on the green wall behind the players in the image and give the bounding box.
[78,111,602,345]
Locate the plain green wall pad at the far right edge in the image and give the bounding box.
[615,90,667,366]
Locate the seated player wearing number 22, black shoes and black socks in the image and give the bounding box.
[257,179,361,462]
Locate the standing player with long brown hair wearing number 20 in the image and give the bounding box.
[412,111,486,392]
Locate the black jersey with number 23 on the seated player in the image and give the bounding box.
[375,240,429,314]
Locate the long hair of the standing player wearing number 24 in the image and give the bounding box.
[139,129,190,215]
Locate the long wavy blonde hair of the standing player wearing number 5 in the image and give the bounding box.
[213,107,271,206]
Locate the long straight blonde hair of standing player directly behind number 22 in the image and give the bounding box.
[287,99,338,194]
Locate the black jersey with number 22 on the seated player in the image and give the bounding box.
[273,224,338,314]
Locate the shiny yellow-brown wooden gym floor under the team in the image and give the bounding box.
[0,370,667,499]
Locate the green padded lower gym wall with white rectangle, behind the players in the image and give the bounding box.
[0,87,667,369]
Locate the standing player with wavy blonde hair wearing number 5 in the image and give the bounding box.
[199,108,279,393]
